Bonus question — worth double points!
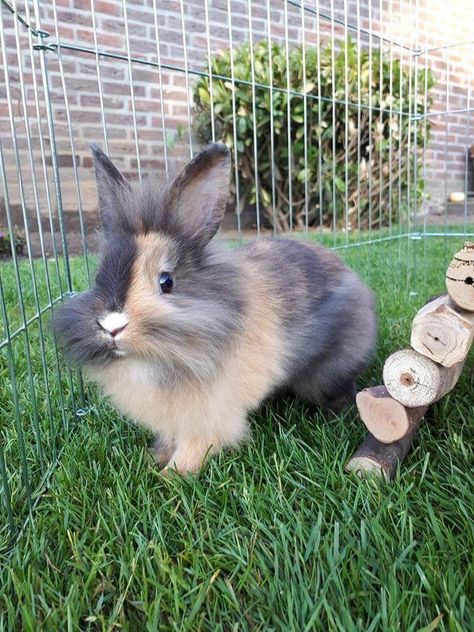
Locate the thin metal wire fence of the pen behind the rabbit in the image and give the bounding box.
[0,0,474,551]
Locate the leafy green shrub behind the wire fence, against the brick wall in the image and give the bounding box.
[194,39,433,229]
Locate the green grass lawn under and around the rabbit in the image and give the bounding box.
[0,238,474,632]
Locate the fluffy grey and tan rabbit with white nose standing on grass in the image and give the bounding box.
[54,143,377,473]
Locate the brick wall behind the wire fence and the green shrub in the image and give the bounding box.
[0,0,474,244]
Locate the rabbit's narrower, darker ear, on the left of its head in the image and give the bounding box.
[90,143,129,231]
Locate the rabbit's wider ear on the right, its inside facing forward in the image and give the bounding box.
[168,143,230,246]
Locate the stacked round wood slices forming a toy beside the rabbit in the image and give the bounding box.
[346,242,474,479]
